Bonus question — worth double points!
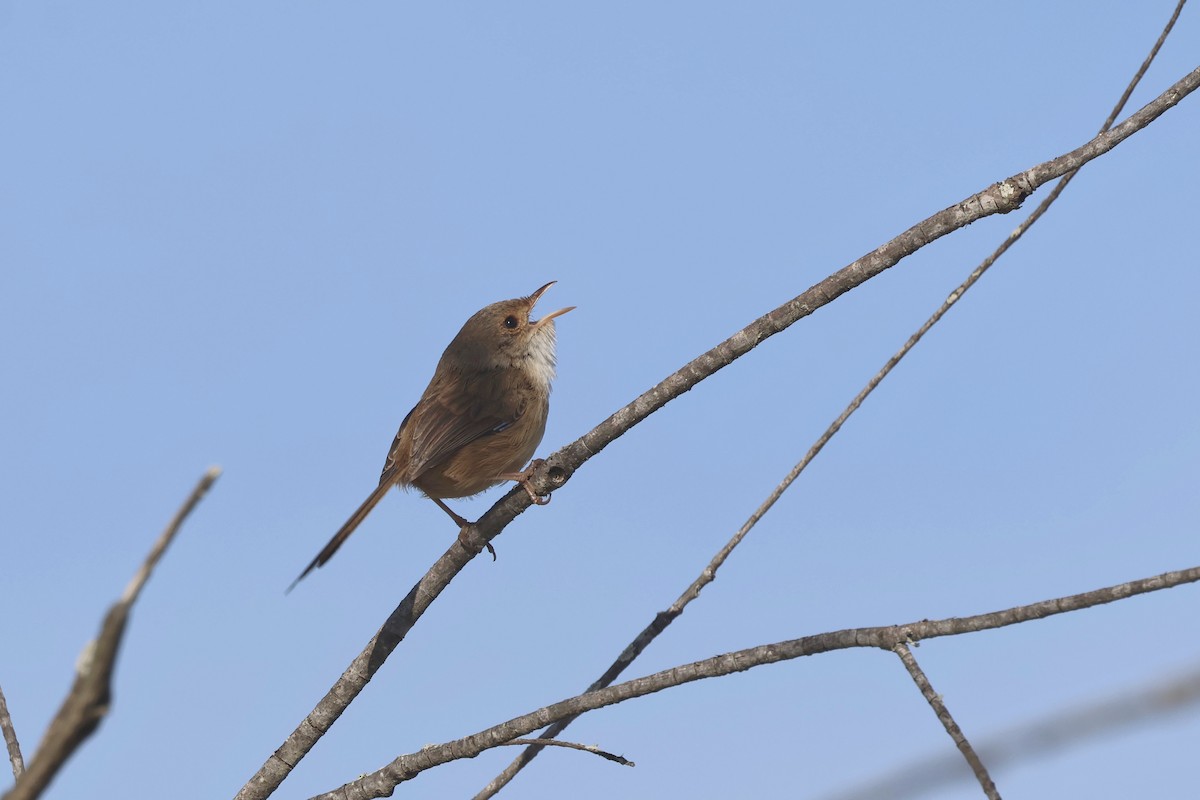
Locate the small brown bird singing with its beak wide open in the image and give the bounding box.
[288,281,575,591]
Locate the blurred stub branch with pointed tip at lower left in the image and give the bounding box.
[5,467,221,800]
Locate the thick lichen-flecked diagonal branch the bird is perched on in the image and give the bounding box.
[236,68,1200,800]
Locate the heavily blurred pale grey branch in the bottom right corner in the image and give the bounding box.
[826,667,1200,800]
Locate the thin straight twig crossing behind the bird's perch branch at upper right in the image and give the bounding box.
[474,0,1187,800]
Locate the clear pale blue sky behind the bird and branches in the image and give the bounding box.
[0,1,1200,800]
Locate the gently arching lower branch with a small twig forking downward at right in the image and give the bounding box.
[313,566,1200,800]
